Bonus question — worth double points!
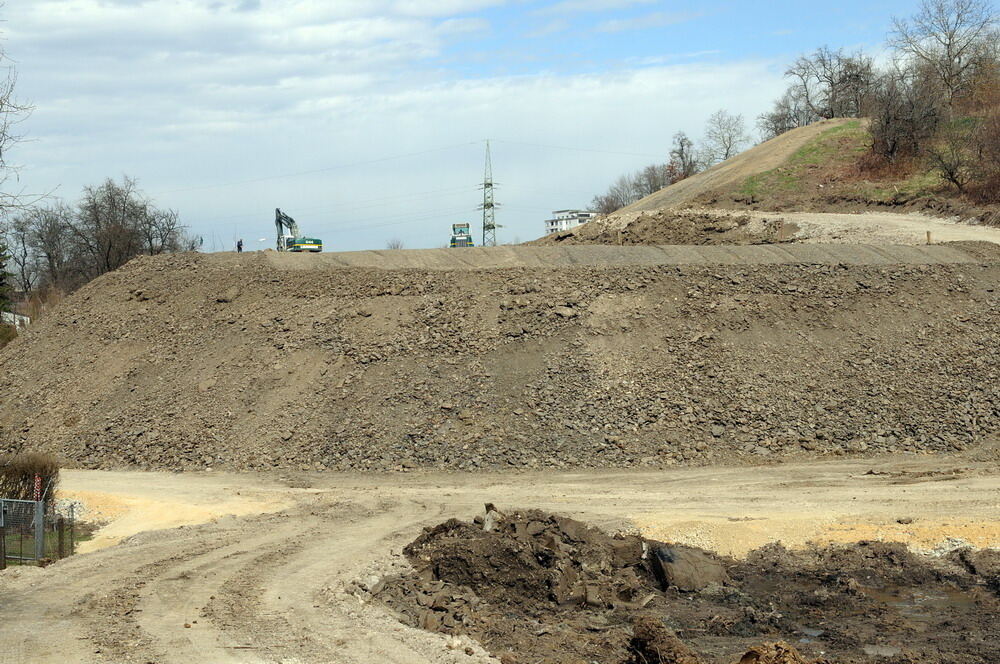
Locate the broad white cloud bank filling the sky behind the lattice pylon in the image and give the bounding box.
[6,0,783,248]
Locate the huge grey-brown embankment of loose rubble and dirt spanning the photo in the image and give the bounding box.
[0,247,1000,469]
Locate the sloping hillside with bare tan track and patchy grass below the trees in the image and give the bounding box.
[533,119,1000,245]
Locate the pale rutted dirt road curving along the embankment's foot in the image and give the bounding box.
[0,456,1000,663]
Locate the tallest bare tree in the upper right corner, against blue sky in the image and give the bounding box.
[889,0,1000,103]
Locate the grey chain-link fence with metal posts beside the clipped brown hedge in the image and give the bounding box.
[0,498,76,569]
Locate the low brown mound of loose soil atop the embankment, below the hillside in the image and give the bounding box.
[529,210,784,245]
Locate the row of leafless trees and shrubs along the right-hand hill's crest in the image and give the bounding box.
[592,0,1000,214]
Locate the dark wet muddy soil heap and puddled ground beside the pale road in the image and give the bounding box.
[377,506,1000,664]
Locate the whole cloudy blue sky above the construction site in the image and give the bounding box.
[0,0,916,251]
